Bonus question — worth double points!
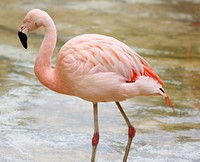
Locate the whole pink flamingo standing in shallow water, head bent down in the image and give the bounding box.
[18,9,174,162]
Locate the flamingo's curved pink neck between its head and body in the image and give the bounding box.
[34,16,57,91]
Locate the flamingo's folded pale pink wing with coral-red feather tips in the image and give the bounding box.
[62,34,164,85]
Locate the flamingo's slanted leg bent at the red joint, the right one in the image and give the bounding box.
[115,102,136,162]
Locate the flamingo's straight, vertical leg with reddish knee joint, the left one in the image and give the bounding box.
[91,103,99,162]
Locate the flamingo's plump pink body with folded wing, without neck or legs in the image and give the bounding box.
[55,34,167,103]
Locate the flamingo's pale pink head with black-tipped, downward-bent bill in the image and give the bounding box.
[18,9,45,49]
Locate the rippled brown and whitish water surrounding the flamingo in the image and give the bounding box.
[0,0,200,162]
